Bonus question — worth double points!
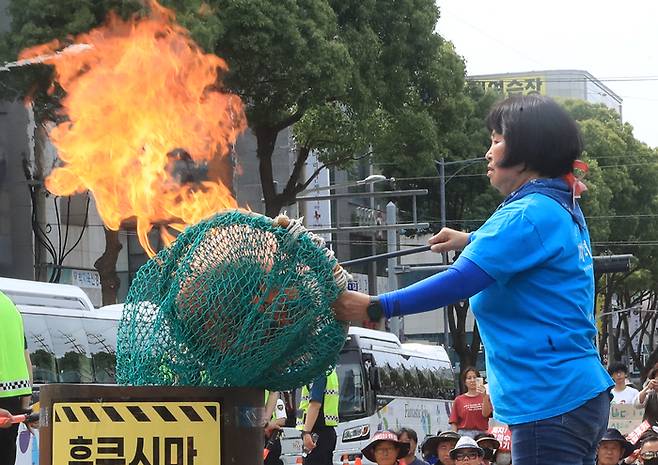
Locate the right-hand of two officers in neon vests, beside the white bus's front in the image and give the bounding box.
[297,370,338,465]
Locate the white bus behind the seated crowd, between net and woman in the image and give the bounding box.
[281,327,455,465]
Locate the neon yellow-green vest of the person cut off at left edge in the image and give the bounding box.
[0,292,32,398]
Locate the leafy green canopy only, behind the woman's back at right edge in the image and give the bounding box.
[564,100,658,282]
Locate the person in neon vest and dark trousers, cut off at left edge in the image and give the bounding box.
[0,292,32,465]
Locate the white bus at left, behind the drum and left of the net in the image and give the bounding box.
[0,278,122,465]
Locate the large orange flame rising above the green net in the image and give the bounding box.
[21,1,246,256]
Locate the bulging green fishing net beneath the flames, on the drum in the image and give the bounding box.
[117,211,348,390]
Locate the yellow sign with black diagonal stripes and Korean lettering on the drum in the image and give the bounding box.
[52,402,220,465]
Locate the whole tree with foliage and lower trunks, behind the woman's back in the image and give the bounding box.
[564,100,658,376]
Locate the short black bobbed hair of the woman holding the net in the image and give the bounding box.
[487,94,583,178]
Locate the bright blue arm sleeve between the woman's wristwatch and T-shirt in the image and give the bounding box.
[379,257,494,318]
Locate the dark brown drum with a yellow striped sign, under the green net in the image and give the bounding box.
[39,384,263,465]
